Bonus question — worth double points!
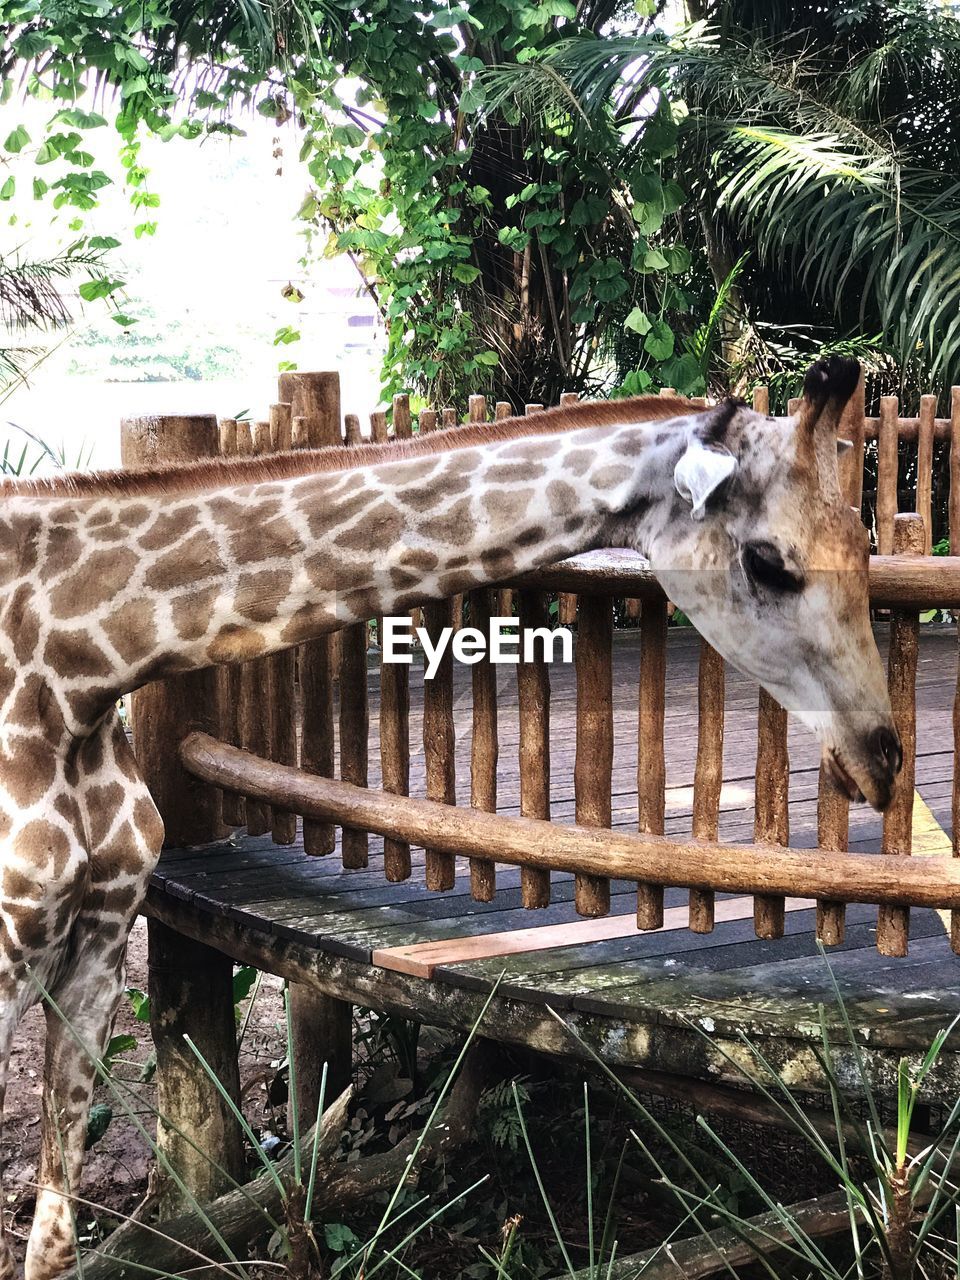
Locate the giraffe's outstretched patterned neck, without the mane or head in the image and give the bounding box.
[0,419,695,736]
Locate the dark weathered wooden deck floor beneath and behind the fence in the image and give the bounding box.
[147,627,960,1092]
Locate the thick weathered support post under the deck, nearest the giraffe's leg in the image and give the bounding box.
[147,921,244,1217]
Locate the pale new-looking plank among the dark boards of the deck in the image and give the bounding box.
[372,897,813,978]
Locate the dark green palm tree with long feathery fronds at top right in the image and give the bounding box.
[483,0,960,394]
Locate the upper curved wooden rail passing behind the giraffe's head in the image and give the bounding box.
[509,550,960,609]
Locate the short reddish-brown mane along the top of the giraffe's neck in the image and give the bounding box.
[0,396,704,498]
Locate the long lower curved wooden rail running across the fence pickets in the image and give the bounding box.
[180,733,960,908]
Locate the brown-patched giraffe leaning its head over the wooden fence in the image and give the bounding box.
[0,360,900,1280]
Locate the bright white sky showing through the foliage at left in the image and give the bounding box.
[0,104,381,466]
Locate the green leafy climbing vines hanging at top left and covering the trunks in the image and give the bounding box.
[0,0,701,403]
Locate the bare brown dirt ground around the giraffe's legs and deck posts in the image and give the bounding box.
[0,919,285,1258]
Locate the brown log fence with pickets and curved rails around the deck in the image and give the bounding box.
[124,374,960,955]
